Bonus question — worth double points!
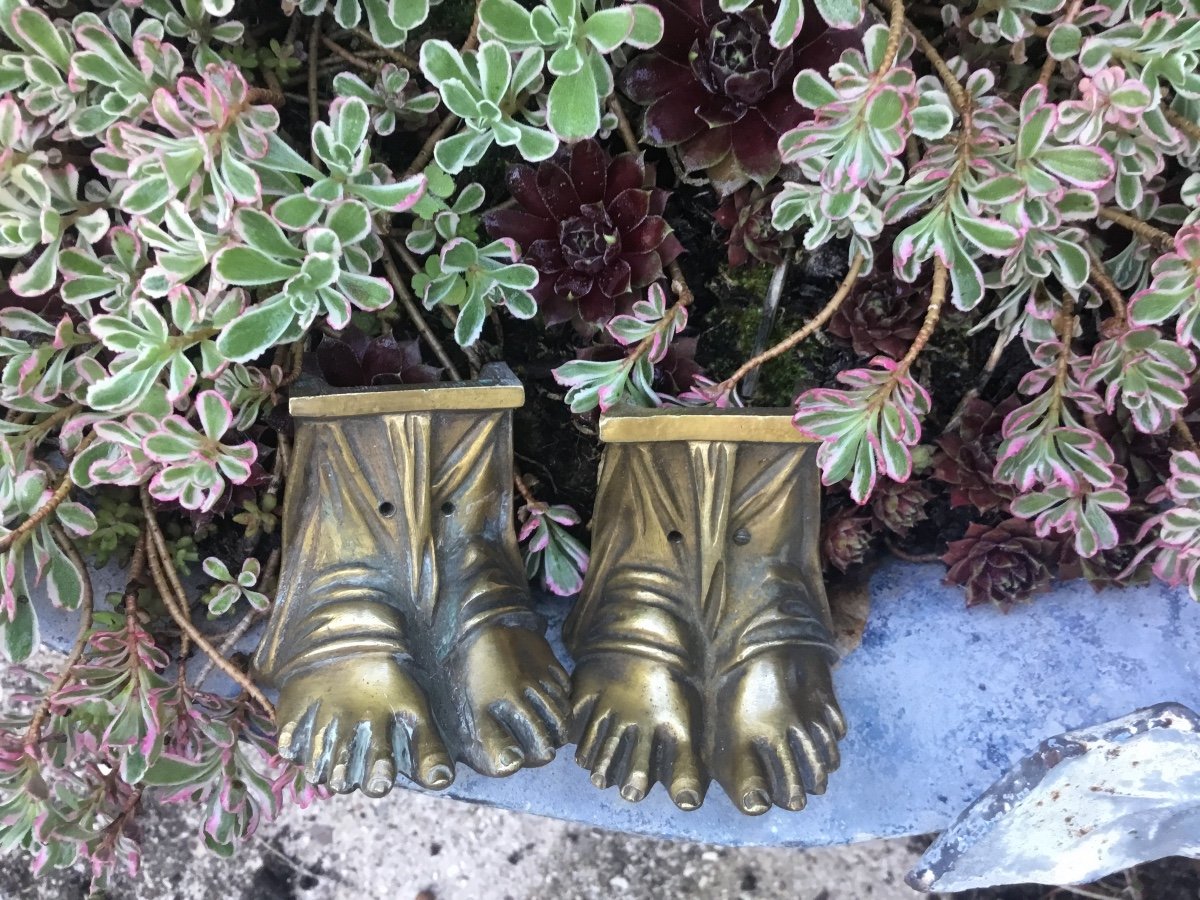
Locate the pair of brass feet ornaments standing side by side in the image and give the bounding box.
[256,366,845,814]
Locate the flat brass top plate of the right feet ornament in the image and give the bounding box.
[600,407,812,444]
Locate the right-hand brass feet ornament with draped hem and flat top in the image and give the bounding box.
[566,409,846,815]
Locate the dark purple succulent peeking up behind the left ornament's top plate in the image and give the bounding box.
[317,325,442,388]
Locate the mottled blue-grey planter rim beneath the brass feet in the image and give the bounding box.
[35,562,1200,847]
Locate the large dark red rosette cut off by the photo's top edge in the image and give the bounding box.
[619,0,862,194]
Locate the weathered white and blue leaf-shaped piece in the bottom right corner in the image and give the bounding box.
[908,703,1200,892]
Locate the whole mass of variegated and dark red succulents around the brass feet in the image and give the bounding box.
[7,0,1200,883]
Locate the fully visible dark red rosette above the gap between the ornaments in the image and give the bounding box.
[484,140,683,325]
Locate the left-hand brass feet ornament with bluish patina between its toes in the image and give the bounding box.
[254,364,569,797]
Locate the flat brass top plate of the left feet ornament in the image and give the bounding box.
[288,362,524,418]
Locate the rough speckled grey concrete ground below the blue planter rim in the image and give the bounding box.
[0,791,924,900]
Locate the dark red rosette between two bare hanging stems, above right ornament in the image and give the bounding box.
[828,260,929,360]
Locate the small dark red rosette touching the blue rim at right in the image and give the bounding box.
[942,518,1058,612]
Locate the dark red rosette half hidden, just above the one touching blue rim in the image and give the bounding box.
[934,396,1020,512]
